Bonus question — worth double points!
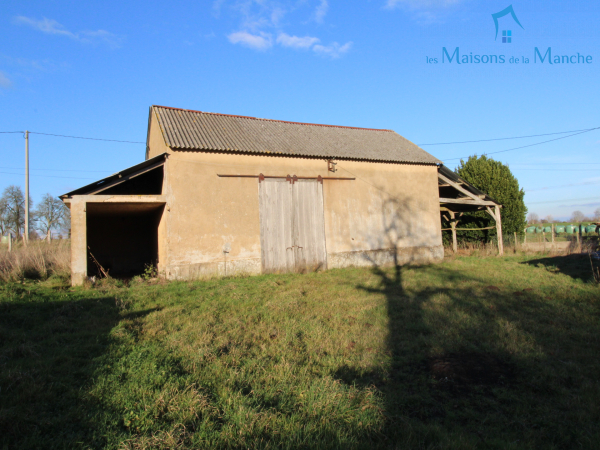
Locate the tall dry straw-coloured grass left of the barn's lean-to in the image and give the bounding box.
[0,240,71,282]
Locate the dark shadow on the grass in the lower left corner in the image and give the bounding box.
[0,285,157,448]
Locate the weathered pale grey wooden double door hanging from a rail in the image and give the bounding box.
[259,178,327,273]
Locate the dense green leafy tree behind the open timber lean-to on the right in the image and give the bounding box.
[456,155,528,241]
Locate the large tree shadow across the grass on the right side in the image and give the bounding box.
[336,258,600,448]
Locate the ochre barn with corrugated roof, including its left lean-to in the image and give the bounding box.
[61,106,444,285]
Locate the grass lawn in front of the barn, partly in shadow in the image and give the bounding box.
[0,255,600,449]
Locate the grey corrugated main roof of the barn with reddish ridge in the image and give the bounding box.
[151,106,441,164]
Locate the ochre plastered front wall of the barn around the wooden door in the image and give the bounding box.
[162,149,443,279]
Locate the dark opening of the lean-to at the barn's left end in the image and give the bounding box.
[86,203,164,278]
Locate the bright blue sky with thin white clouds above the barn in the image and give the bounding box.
[0,0,600,218]
